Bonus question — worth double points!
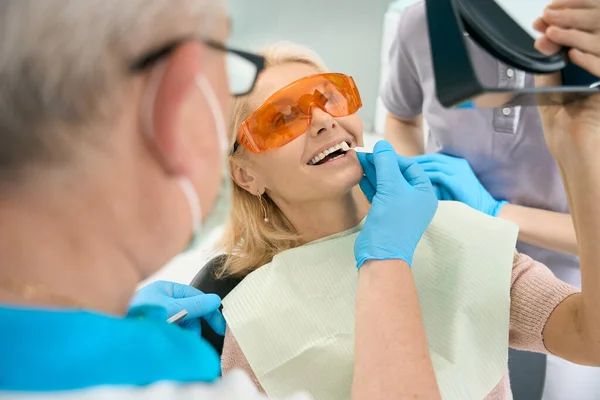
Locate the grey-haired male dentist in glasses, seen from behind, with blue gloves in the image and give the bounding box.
[0,0,439,400]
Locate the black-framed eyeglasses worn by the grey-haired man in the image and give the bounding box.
[130,38,265,96]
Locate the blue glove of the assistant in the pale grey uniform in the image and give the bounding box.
[412,154,508,217]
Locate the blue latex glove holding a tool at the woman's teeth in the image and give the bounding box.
[354,141,438,268]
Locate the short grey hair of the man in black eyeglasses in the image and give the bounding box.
[0,0,222,183]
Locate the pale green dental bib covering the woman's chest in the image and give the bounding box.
[223,202,518,400]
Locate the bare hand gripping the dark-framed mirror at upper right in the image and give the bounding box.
[534,0,600,157]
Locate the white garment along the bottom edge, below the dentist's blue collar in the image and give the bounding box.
[0,371,311,400]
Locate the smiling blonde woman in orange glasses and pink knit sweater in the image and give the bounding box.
[222,44,600,399]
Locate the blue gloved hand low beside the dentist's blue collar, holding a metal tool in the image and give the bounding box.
[129,281,225,335]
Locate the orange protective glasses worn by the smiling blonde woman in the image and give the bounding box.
[234,73,362,153]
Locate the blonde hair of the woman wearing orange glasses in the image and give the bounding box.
[218,42,327,277]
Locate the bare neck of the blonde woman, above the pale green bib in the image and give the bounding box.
[279,186,371,242]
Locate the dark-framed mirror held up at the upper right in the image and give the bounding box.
[425,0,600,108]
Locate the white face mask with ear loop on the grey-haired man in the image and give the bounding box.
[179,75,231,251]
